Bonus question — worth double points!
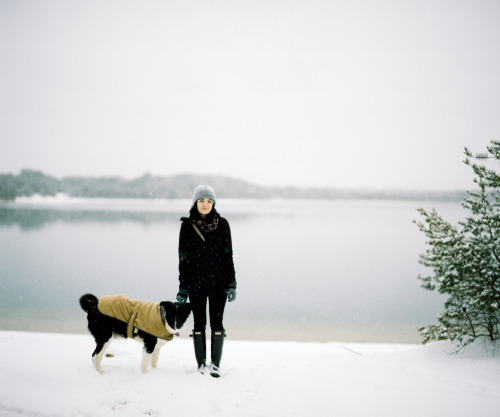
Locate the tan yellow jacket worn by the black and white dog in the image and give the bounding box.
[98,295,174,340]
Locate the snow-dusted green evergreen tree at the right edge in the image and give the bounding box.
[417,141,500,348]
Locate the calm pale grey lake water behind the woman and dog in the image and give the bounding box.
[0,200,463,343]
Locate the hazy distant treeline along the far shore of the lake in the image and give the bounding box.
[0,169,466,201]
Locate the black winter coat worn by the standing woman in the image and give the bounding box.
[179,217,236,296]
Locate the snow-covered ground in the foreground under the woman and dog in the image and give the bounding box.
[0,331,500,417]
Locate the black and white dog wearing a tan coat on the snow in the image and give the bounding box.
[80,294,191,374]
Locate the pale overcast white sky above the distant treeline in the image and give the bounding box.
[0,0,500,190]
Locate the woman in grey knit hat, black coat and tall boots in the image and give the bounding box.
[177,185,236,378]
